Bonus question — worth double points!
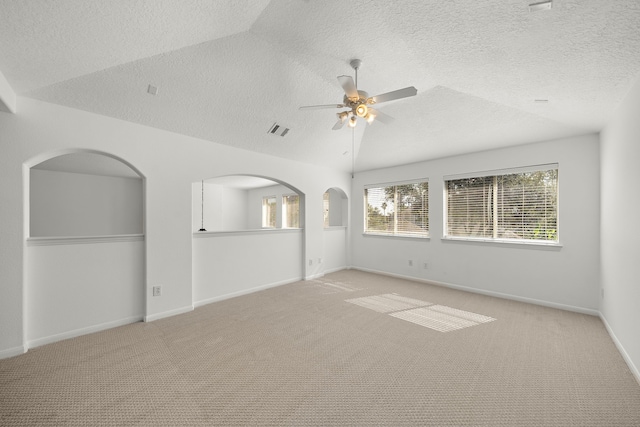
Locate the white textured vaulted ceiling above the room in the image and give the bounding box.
[0,0,640,174]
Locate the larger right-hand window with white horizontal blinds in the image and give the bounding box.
[445,165,558,242]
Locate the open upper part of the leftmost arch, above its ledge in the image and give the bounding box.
[29,151,144,237]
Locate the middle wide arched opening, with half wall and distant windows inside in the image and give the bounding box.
[192,175,305,306]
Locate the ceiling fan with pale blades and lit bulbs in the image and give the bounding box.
[300,59,418,130]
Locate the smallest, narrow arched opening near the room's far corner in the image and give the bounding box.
[322,187,349,273]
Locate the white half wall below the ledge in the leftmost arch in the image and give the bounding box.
[25,237,145,347]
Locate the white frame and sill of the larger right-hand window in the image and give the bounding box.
[442,163,562,247]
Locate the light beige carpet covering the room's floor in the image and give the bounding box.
[0,270,640,426]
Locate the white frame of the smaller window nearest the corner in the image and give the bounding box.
[363,178,431,240]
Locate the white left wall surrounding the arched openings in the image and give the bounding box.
[0,97,349,358]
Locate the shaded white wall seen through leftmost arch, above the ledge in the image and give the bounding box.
[30,169,143,236]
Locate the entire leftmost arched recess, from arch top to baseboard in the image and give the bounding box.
[24,150,145,347]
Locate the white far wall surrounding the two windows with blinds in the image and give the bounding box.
[351,135,600,313]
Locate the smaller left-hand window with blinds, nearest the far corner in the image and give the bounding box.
[364,180,429,237]
